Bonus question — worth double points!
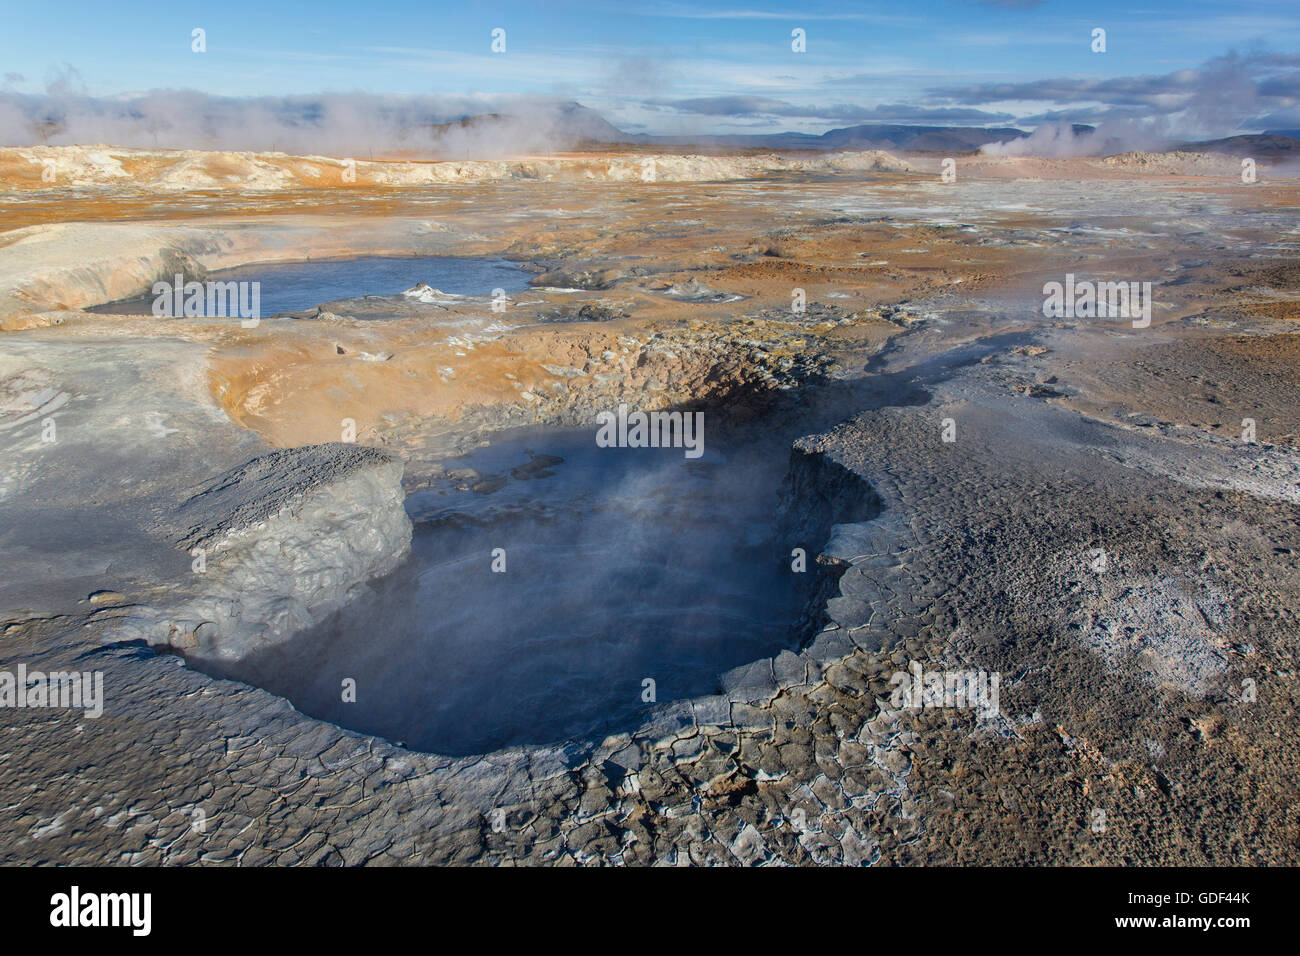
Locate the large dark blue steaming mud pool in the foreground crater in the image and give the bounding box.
[195,429,811,756]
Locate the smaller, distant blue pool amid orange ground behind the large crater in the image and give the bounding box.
[86,256,532,319]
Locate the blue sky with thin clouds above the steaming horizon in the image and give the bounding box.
[0,0,1300,145]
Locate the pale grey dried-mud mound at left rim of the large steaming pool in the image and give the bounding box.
[109,444,411,661]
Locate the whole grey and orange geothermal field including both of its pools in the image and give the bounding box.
[0,147,1300,865]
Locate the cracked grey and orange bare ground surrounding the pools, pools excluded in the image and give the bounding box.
[0,147,1300,865]
